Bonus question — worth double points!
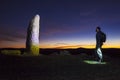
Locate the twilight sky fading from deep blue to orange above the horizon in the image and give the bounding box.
[0,0,120,48]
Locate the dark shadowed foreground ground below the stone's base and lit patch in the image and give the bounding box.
[0,55,120,80]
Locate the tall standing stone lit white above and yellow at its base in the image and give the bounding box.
[26,15,40,55]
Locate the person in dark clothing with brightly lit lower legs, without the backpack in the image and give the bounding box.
[95,26,103,63]
